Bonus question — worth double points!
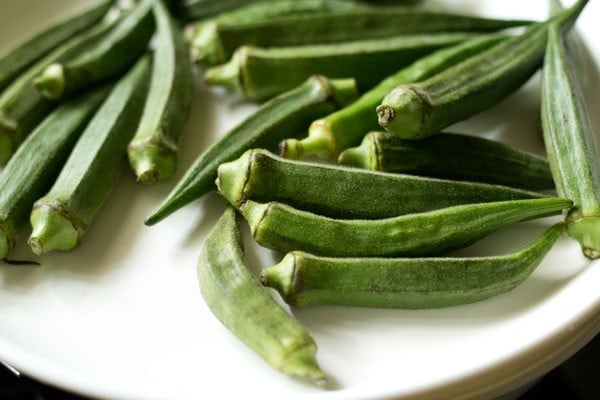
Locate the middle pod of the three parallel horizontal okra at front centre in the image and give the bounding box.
[239,197,572,257]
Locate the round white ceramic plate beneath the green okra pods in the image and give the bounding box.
[0,0,600,400]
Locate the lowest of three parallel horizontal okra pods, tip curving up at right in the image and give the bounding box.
[261,222,564,309]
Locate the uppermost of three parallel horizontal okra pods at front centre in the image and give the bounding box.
[217,149,542,219]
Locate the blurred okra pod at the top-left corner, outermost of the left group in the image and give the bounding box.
[0,0,115,91]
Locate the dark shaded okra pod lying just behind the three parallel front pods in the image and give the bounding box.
[338,131,554,190]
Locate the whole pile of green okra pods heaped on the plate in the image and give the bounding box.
[0,0,600,384]
